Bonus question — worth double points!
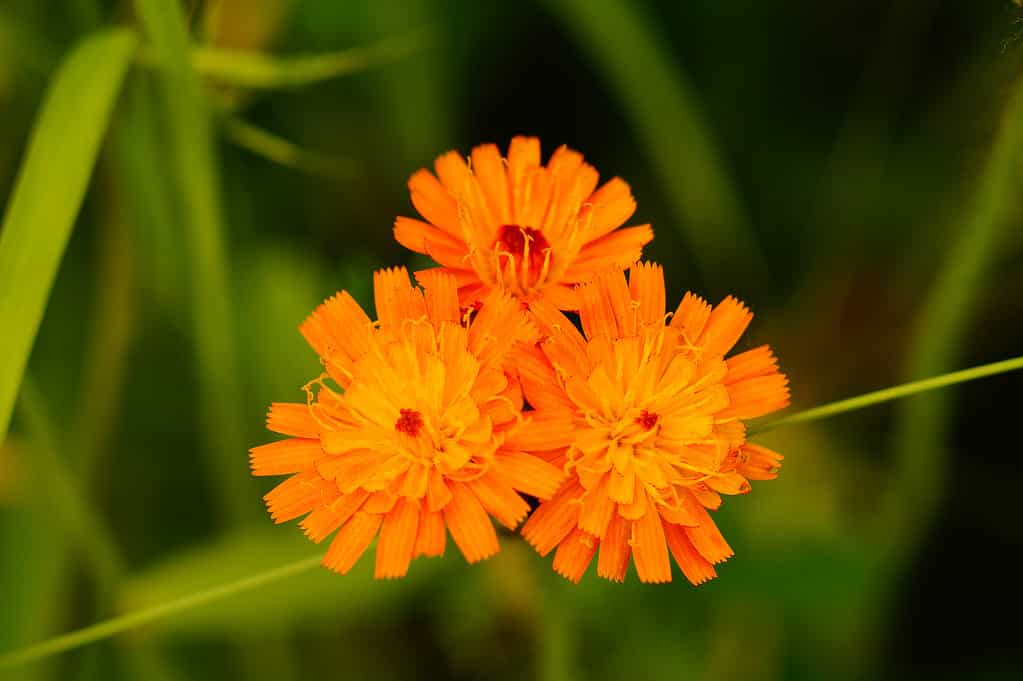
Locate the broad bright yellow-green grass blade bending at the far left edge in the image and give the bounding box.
[0,29,137,440]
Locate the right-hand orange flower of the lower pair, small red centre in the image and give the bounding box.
[515,264,789,584]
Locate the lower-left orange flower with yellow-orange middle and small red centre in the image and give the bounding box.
[251,269,564,578]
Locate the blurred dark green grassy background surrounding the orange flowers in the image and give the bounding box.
[0,0,1023,681]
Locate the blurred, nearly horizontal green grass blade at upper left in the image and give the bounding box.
[191,29,431,90]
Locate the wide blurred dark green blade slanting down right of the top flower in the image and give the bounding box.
[546,0,766,285]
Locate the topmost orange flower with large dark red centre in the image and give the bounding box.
[394,137,654,310]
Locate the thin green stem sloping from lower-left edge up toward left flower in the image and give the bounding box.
[0,554,321,669]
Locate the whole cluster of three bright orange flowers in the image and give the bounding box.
[251,138,789,584]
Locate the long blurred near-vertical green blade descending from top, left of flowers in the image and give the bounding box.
[135,0,252,524]
